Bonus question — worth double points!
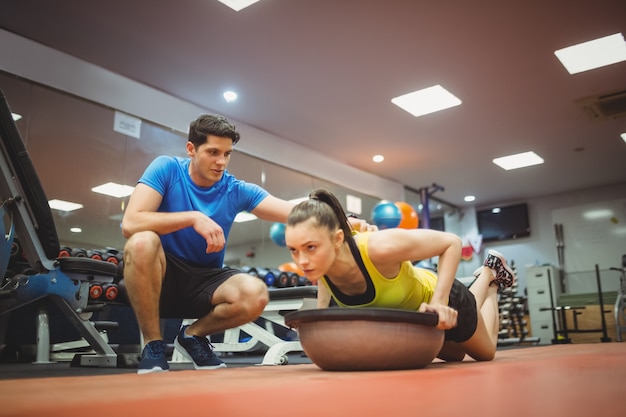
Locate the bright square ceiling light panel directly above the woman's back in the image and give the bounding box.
[391,85,462,117]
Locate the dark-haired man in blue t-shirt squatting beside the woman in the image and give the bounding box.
[122,115,369,374]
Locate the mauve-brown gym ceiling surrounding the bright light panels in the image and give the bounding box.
[0,0,626,206]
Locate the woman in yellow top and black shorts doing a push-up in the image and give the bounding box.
[285,190,515,361]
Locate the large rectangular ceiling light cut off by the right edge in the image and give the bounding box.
[554,33,626,74]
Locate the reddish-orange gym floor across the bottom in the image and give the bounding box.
[0,342,626,417]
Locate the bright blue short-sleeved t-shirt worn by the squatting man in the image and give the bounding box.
[138,156,269,268]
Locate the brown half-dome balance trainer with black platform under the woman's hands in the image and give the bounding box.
[285,308,444,371]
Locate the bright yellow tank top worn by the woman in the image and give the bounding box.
[320,233,437,311]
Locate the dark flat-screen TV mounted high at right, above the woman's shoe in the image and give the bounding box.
[476,203,530,242]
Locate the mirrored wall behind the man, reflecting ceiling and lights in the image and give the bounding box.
[0,73,390,266]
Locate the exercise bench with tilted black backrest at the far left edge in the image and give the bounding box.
[0,91,118,367]
